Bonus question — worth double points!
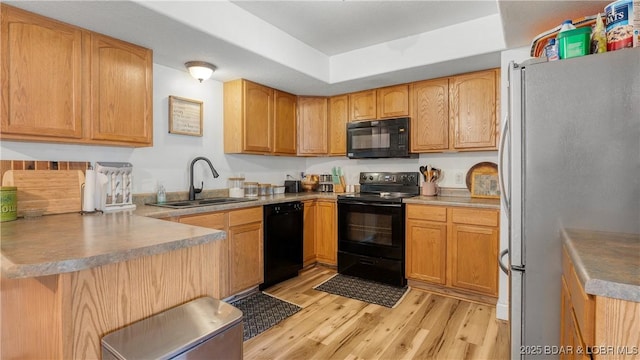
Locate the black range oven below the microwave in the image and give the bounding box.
[338,172,420,286]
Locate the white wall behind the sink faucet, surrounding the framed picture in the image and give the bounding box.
[0,64,305,193]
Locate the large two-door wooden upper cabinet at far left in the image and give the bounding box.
[0,4,153,146]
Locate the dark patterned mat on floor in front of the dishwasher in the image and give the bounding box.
[230,292,302,341]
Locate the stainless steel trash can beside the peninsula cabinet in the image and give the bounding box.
[102,297,242,360]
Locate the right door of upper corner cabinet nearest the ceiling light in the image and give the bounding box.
[273,90,297,155]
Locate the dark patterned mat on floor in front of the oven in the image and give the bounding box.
[314,274,409,308]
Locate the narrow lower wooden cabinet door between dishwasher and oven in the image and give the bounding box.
[316,201,338,265]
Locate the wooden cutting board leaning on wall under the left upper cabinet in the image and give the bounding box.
[2,170,84,216]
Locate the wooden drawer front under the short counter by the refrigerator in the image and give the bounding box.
[562,248,595,345]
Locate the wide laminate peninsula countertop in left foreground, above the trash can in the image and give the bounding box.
[0,211,226,278]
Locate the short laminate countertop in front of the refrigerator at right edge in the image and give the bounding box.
[562,229,640,302]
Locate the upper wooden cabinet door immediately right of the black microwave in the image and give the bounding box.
[411,79,449,152]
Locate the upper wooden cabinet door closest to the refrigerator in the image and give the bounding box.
[449,70,498,149]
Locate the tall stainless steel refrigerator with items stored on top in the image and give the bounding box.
[500,48,640,359]
